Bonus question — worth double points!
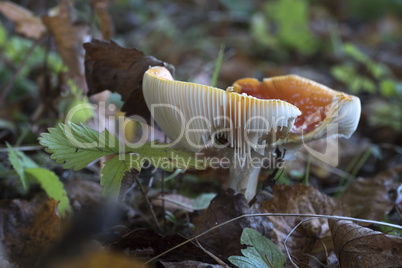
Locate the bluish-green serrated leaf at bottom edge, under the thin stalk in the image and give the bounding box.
[229,228,286,268]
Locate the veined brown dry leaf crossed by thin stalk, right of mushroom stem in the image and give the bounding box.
[259,184,347,263]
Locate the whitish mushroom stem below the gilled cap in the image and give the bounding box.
[229,156,261,202]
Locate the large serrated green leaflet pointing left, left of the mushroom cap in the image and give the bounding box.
[39,123,120,170]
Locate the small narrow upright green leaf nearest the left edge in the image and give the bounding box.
[7,143,38,191]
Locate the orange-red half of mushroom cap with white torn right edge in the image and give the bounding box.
[233,75,361,143]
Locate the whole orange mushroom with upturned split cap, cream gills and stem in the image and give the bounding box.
[143,67,360,201]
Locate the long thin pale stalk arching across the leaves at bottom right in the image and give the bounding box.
[144,213,402,264]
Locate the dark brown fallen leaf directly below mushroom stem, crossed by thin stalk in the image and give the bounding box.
[196,189,272,259]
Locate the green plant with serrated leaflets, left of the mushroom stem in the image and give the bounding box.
[39,123,203,199]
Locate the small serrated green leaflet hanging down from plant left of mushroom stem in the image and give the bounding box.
[101,155,132,199]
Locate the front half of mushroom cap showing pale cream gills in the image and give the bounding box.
[143,66,301,156]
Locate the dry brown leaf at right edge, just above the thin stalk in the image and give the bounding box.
[341,165,402,220]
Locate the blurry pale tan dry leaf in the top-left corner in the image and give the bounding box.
[0,1,46,39]
